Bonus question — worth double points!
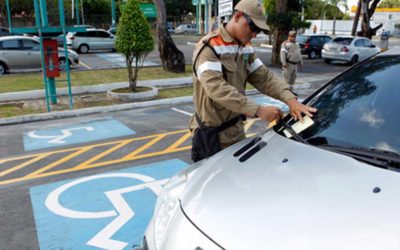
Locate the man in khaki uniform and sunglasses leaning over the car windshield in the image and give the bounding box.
[189,0,316,161]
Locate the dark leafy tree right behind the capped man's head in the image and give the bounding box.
[264,0,311,65]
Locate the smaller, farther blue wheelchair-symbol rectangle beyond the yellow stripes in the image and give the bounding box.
[23,119,135,151]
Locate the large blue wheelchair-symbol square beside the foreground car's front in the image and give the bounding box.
[30,159,187,250]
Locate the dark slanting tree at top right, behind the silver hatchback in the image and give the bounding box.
[351,0,383,39]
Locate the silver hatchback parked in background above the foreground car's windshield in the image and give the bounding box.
[322,36,380,64]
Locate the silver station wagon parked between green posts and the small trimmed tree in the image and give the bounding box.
[67,29,116,54]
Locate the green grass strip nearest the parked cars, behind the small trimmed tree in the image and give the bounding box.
[0,65,192,93]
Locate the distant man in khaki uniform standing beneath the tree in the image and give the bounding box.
[280,31,303,90]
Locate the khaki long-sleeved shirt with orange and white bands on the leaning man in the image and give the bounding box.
[189,26,295,147]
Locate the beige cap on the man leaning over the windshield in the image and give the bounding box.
[235,0,269,30]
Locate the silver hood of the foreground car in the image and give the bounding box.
[181,131,400,250]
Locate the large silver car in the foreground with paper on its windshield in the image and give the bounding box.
[142,50,400,250]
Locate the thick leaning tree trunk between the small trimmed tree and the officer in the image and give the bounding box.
[153,0,185,73]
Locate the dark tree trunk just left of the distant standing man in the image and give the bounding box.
[271,0,290,65]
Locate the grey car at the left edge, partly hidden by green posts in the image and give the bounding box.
[0,36,79,75]
